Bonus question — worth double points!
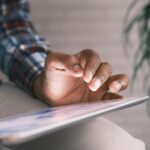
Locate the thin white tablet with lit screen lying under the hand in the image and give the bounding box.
[0,96,149,145]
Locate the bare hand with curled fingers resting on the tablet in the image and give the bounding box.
[34,49,128,106]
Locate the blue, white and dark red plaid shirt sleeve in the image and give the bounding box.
[0,0,50,94]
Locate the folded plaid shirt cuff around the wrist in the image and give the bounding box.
[10,51,47,96]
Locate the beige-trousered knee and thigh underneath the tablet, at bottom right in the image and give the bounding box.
[15,118,145,150]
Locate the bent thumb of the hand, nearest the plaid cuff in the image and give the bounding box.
[45,53,83,77]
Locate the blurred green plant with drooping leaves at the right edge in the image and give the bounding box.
[124,0,150,93]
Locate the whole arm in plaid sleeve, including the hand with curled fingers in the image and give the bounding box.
[0,0,128,106]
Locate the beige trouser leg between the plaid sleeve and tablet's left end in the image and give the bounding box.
[0,83,47,118]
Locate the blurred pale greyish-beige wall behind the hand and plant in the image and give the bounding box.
[31,0,150,149]
